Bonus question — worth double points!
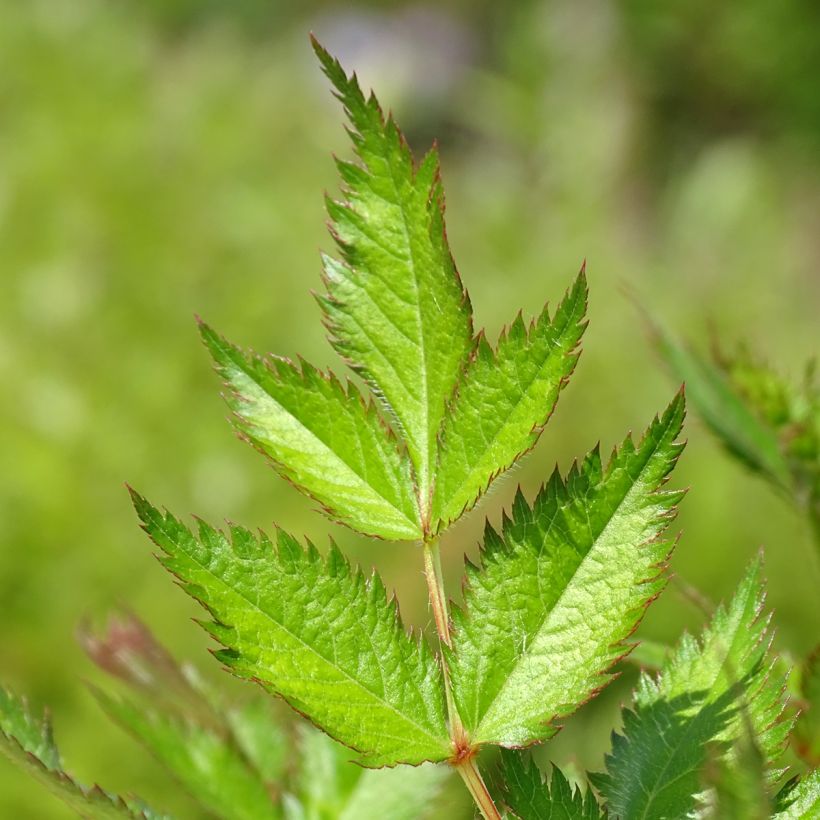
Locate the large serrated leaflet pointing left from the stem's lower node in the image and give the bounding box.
[132,492,451,766]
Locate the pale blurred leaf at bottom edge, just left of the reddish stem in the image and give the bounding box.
[285,726,450,820]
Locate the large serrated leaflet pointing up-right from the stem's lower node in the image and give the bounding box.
[447,393,684,746]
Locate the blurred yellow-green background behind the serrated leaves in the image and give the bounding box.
[0,0,820,819]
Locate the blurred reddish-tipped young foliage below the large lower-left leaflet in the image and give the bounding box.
[79,613,288,820]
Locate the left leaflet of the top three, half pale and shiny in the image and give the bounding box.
[200,324,421,540]
